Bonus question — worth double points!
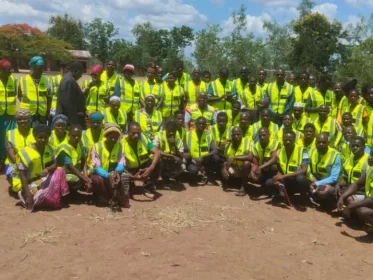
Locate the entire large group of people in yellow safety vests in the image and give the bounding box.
[0,56,373,232]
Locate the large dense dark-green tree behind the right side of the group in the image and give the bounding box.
[289,13,347,72]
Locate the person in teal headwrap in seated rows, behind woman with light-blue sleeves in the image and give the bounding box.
[82,112,104,153]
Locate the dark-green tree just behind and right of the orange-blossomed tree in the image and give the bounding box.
[47,14,86,50]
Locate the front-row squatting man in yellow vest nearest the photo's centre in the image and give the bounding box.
[186,117,220,185]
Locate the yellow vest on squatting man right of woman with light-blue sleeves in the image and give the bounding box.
[122,134,150,168]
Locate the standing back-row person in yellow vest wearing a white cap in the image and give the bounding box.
[120,64,141,121]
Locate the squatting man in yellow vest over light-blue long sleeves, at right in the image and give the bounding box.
[309,132,342,201]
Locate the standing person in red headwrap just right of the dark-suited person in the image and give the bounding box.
[83,64,110,116]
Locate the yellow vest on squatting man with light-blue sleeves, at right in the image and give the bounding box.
[309,147,340,180]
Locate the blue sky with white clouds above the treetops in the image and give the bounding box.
[0,0,373,40]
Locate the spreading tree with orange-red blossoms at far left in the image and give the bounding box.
[0,24,72,70]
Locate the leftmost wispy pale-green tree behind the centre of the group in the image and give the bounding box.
[192,24,227,73]
